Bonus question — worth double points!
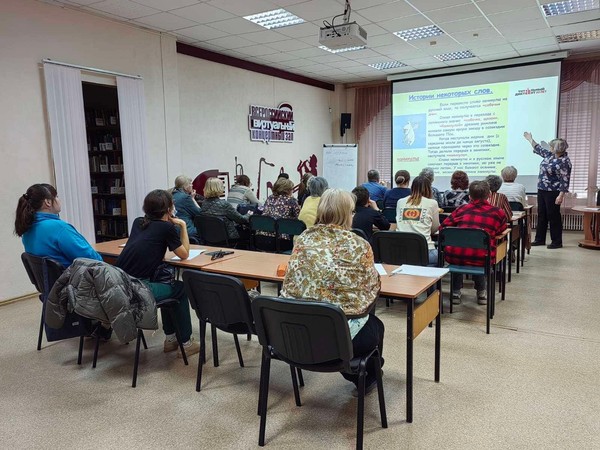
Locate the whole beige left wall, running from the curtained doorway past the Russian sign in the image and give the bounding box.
[0,0,339,302]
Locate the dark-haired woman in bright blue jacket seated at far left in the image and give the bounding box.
[15,184,102,267]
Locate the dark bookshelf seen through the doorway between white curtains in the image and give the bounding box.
[83,83,128,242]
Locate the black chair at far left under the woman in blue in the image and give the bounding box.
[21,253,91,364]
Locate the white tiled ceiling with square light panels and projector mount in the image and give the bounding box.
[42,0,600,83]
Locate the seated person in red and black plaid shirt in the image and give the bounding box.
[440,181,506,305]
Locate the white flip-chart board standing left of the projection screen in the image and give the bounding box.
[323,144,358,192]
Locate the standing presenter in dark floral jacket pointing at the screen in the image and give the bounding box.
[523,131,572,249]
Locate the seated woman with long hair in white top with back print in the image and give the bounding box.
[396,175,440,266]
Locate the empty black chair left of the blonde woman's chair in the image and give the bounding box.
[182,270,256,392]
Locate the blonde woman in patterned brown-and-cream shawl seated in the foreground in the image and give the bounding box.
[281,189,384,392]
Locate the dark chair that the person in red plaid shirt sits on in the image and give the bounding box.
[438,227,496,334]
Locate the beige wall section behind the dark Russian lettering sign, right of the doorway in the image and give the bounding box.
[178,55,337,200]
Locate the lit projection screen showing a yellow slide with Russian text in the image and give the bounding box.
[392,63,560,192]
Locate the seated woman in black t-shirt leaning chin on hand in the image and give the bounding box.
[116,189,200,356]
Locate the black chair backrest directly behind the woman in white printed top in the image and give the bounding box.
[371,231,429,266]
